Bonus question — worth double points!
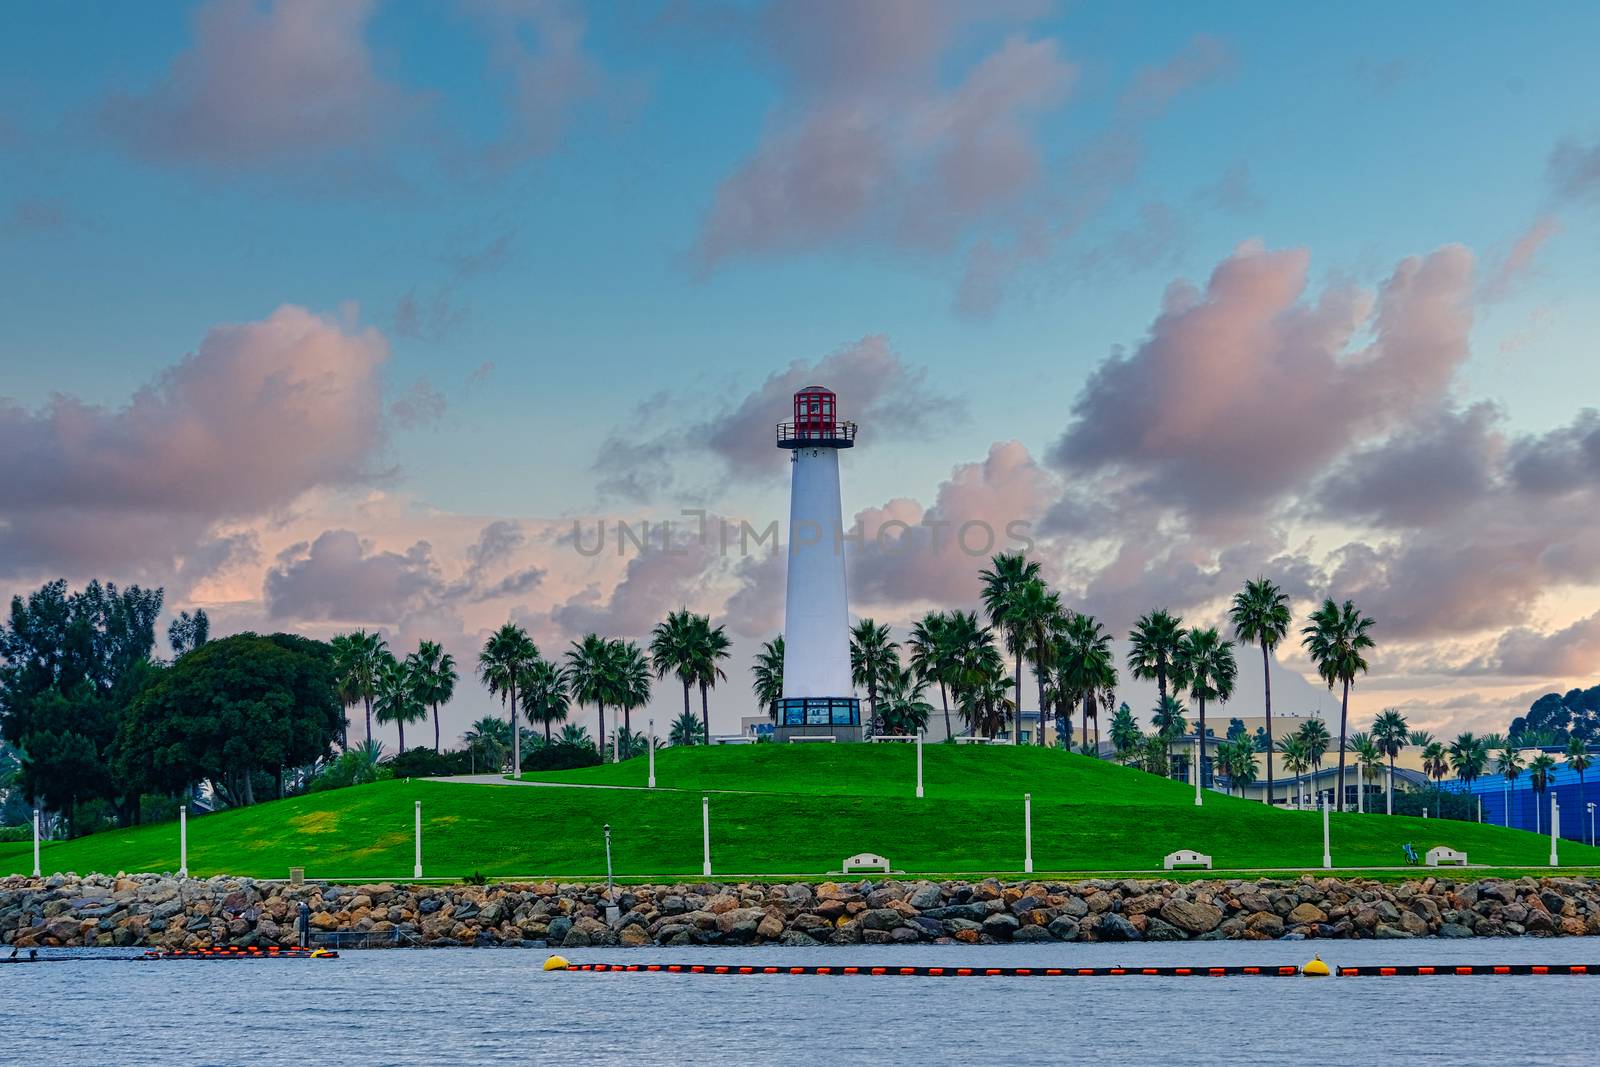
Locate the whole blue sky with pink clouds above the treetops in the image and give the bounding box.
[0,0,1600,751]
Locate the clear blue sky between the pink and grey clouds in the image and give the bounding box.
[0,0,1600,748]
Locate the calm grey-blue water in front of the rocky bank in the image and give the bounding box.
[0,939,1600,1067]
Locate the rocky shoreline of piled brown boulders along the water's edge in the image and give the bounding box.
[9,875,1600,949]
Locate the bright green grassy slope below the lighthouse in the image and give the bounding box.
[0,745,1600,880]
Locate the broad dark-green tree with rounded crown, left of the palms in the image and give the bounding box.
[117,632,342,805]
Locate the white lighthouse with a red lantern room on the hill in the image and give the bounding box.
[774,386,861,741]
